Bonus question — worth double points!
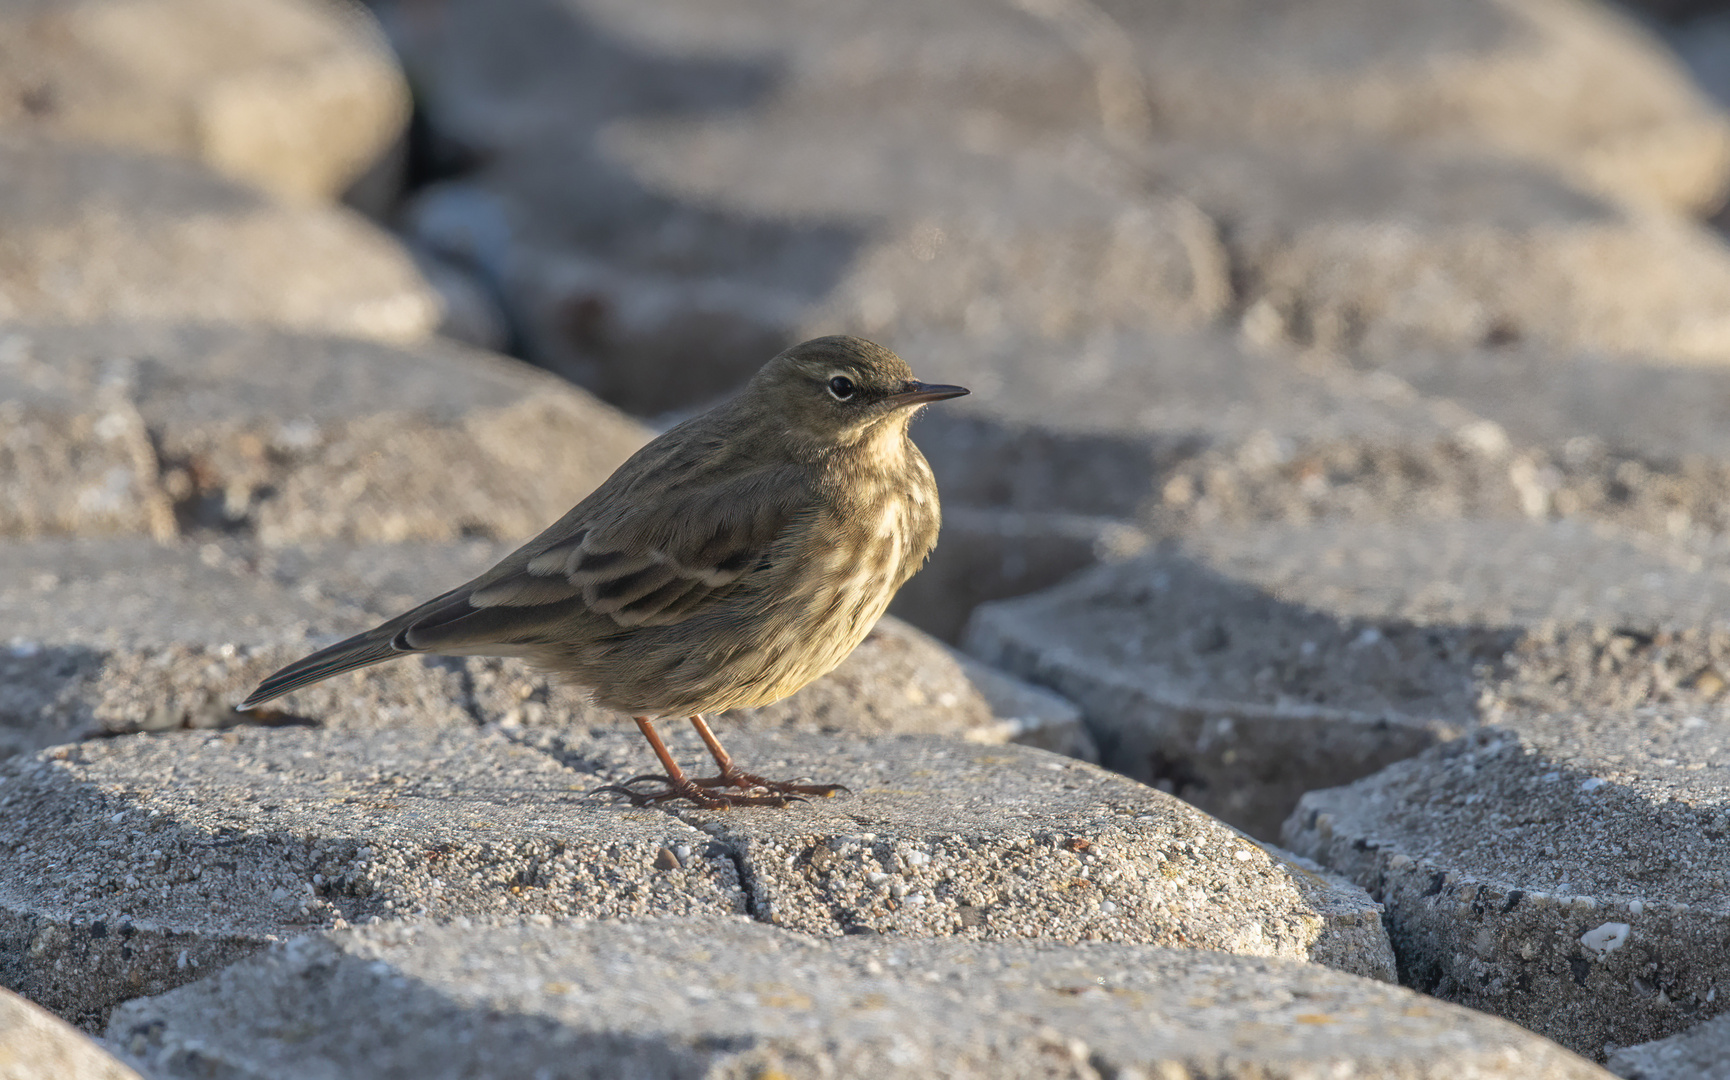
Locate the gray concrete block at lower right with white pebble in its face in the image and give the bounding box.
[1285,713,1730,1059]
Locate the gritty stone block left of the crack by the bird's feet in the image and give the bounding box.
[0,729,744,1028]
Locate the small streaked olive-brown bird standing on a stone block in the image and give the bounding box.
[239,336,967,807]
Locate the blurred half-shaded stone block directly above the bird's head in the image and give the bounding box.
[408,100,1230,412]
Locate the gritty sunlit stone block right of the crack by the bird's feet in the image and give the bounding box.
[535,723,1391,978]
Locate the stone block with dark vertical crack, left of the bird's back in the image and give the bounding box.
[0,322,649,543]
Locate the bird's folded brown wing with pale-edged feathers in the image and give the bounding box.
[396,469,810,653]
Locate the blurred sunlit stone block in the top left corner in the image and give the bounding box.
[0,0,408,199]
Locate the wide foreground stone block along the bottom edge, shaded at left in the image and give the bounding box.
[109,921,1607,1080]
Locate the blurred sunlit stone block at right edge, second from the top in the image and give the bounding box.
[1147,140,1730,363]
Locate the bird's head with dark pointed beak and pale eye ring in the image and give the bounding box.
[746,334,967,447]
